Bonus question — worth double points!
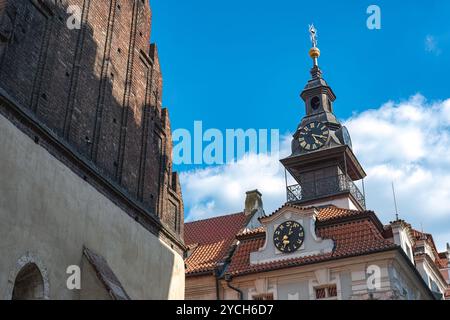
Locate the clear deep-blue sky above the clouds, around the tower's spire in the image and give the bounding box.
[151,0,450,138]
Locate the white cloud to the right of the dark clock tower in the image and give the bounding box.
[346,95,450,249]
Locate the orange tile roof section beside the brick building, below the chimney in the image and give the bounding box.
[184,213,248,275]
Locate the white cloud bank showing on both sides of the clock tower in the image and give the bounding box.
[181,95,450,249]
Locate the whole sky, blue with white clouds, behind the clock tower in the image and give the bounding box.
[151,0,450,248]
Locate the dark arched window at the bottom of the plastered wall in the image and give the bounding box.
[12,263,45,300]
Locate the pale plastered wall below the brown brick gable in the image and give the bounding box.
[0,116,185,299]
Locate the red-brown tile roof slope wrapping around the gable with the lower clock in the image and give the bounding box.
[227,219,397,276]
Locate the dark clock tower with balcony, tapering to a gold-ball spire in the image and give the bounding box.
[281,26,366,210]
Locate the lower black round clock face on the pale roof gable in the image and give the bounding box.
[273,221,305,253]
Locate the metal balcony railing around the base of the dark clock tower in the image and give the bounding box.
[287,175,366,209]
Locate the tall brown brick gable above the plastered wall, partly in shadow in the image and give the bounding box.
[0,0,183,239]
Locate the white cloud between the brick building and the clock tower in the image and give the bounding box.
[180,135,291,221]
